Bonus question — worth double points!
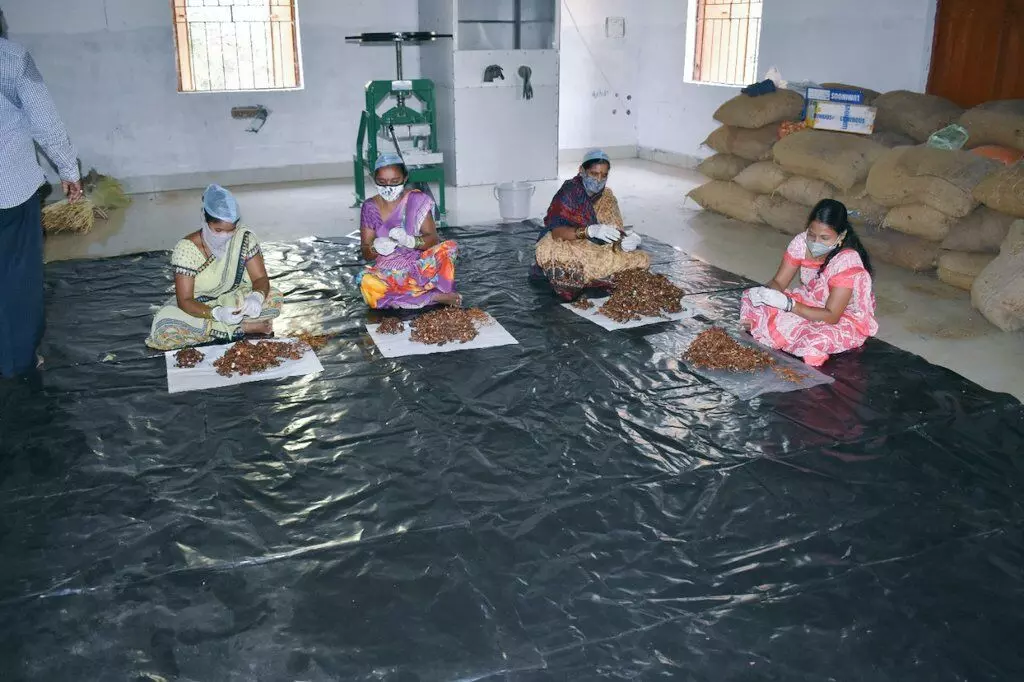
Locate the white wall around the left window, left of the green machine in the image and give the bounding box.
[3,0,419,188]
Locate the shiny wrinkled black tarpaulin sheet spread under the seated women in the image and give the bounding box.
[0,220,1024,682]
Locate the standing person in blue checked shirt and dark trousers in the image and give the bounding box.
[0,25,82,378]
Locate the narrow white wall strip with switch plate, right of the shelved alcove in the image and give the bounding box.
[559,0,634,150]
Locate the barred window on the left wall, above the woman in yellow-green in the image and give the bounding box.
[171,0,302,92]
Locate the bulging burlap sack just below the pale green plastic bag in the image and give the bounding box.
[867,146,1000,218]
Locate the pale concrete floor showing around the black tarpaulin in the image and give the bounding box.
[46,160,1024,400]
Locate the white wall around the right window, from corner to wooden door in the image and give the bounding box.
[630,0,936,156]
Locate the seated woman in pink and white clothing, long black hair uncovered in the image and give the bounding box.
[739,199,879,367]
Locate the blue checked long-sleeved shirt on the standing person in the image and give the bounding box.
[0,38,81,209]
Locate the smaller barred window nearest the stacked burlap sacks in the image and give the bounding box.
[691,0,763,85]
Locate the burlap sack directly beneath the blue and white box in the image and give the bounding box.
[772,130,887,190]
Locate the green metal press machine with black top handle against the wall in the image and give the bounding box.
[345,31,452,224]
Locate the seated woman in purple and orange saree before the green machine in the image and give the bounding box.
[358,154,462,308]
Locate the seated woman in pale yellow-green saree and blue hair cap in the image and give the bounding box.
[145,184,282,350]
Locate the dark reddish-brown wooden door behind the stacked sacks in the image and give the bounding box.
[928,0,1024,108]
